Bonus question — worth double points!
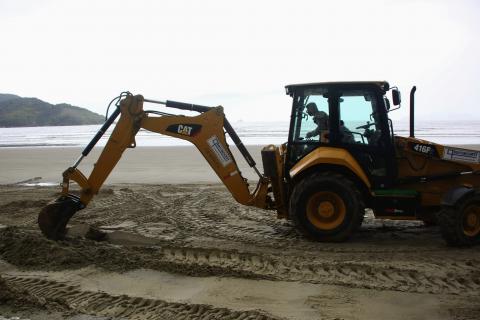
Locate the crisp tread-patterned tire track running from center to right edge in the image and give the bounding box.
[154,247,480,295]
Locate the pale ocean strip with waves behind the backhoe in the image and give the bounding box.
[0,120,480,148]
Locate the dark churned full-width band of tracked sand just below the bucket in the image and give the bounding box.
[0,228,474,295]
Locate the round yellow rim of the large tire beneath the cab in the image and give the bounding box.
[307,191,346,230]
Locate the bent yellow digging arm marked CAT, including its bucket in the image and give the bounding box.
[38,94,274,240]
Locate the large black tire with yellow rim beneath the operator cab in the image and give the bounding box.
[289,172,365,242]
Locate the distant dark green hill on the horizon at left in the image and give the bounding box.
[0,93,104,127]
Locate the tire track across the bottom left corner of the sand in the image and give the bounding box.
[2,275,279,320]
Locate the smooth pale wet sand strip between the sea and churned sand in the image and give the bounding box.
[0,146,263,184]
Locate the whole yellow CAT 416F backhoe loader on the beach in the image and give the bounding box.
[38,81,480,246]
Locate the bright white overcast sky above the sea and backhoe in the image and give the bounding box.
[0,0,480,121]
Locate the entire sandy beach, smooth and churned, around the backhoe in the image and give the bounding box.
[0,147,480,319]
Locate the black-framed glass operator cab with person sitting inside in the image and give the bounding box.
[286,81,398,188]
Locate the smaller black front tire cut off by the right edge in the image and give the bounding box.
[438,193,480,247]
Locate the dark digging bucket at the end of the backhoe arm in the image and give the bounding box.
[38,195,84,240]
